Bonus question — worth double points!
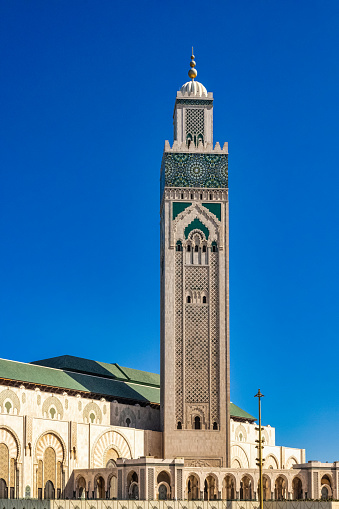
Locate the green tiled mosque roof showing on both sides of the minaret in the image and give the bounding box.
[0,355,256,421]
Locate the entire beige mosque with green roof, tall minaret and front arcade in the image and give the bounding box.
[0,55,339,500]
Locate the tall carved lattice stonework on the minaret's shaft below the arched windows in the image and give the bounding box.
[175,244,220,427]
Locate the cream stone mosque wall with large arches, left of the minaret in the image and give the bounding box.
[0,385,162,496]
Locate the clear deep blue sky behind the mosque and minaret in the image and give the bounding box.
[0,0,339,461]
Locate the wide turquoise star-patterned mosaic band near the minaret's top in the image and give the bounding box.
[161,152,228,190]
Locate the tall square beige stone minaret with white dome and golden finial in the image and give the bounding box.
[160,53,230,467]
